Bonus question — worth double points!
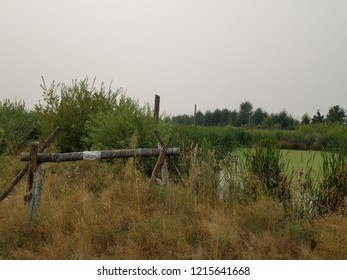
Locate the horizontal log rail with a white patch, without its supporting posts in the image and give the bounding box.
[21,148,180,163]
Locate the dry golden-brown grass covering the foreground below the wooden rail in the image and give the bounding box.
[0,156,347,259]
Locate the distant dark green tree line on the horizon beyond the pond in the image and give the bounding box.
[165,101,347,130]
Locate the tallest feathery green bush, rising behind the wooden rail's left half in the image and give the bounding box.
[36,78,122,152]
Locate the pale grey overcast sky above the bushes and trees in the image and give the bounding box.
[0,0,347,118]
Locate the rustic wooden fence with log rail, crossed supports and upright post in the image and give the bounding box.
[0,95,184,221]
